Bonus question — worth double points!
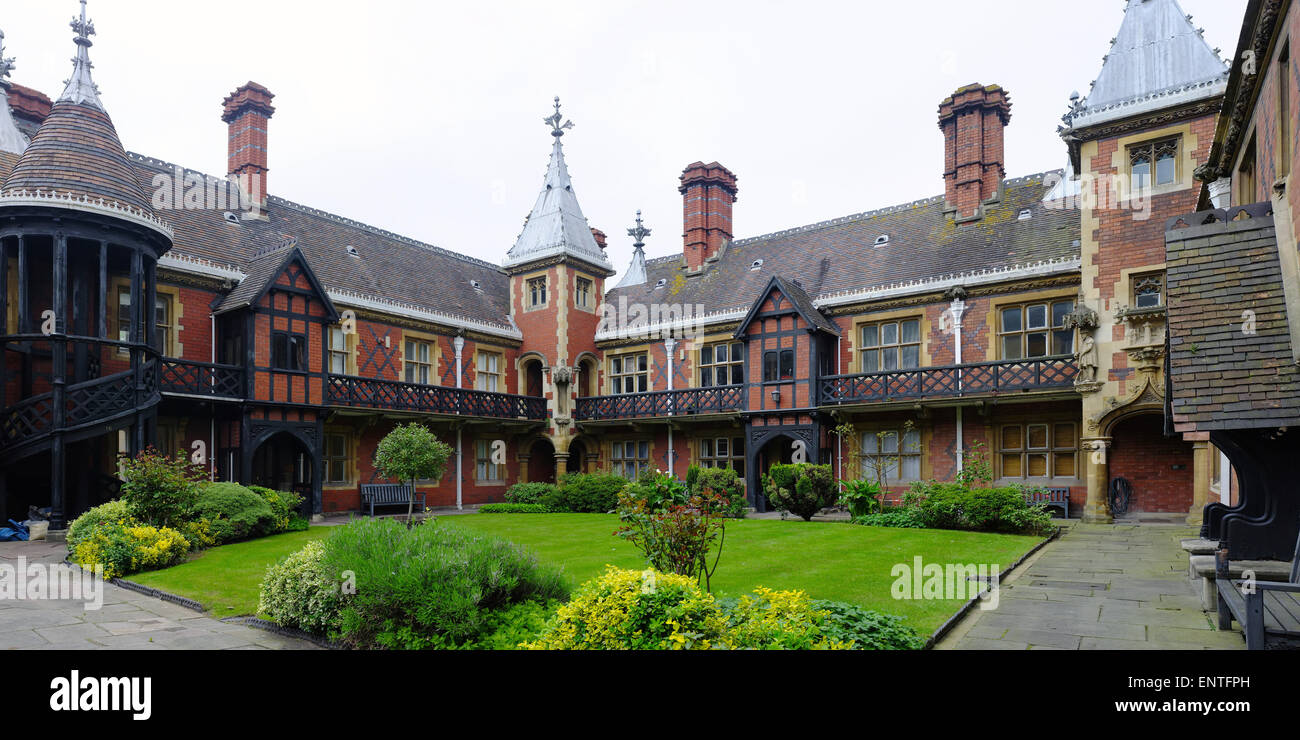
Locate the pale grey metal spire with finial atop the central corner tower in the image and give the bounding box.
[504,98,614,273]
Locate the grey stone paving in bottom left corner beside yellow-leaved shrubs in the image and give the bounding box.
[0,542,316,650]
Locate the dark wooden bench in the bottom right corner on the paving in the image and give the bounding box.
[1216,525,1300,650]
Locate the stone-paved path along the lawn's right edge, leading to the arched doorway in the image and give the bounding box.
[937,523,1245,650]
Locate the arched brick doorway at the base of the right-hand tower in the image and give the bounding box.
[1108,414,1195,514]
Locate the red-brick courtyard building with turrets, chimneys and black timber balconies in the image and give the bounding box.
[0,0,1258,522]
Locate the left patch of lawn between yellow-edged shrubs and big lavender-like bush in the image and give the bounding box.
[127,527,330,618]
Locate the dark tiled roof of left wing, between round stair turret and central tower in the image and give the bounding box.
[129,153,514,330]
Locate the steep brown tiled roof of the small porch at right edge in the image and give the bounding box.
[1166,203,1300,432]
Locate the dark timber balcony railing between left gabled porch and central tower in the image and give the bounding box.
[325,375,546,420]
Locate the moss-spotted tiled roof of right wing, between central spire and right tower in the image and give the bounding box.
[608,173,1079,313]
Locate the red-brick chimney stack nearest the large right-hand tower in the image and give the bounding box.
[939,83,1011,222]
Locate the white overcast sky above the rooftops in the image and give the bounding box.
[0,0,1245,279]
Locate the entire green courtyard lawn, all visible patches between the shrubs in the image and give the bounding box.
[130,514,1037,636]
